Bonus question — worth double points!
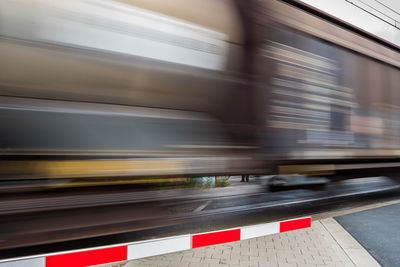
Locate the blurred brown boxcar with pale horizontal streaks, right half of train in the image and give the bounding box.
[248,1,400,177]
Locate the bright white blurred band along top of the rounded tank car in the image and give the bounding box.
[1,0,226,69]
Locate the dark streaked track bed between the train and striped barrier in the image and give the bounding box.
[0,178,400,258]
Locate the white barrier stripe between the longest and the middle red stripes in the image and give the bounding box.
[128,235,191,260]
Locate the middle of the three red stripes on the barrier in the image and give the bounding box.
[192,229,240,248]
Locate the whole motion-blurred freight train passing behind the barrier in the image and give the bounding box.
[0,0,400,183]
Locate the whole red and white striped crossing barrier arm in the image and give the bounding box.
[0,217,311,267]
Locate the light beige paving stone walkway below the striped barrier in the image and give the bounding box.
[119,219,379,267]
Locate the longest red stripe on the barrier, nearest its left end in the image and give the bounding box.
[46,246,128,267]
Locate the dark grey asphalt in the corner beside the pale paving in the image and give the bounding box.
[335,204,400,266]
